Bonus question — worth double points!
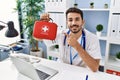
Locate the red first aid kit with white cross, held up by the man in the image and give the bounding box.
[32,21,57,40]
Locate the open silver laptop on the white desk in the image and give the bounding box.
[10,54,58,80]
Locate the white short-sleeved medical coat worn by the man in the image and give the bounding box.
[57,29,101,67]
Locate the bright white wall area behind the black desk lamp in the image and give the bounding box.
[0,0,20,45]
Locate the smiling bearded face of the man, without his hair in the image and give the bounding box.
[67,13,84,33]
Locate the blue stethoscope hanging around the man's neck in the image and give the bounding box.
[63,30,86,65]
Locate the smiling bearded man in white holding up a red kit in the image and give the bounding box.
[41,7,101,72]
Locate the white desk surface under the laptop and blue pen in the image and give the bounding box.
[0,58,120,80]
